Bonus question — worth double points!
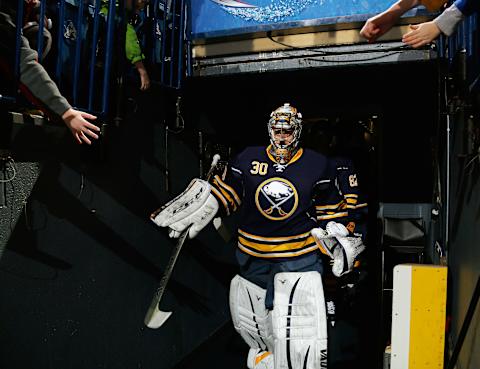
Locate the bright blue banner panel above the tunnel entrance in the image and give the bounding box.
[190,0,432,39]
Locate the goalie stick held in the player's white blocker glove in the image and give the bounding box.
[143,154,220,329]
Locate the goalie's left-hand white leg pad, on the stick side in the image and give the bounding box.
[230,275,273,356]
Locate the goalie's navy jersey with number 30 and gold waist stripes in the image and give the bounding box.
[210,147,342,259]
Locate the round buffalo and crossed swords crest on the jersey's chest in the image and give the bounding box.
[255,178,298,220]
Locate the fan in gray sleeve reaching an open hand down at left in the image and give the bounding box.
[0,4,100,145]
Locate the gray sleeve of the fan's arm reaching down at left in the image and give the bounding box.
[20,37,71,116]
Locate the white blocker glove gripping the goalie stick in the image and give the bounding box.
[151,178,218,238]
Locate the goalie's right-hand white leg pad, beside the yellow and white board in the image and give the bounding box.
[272,272,327,369]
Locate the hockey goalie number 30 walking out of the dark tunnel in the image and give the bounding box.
[151,104,365,369]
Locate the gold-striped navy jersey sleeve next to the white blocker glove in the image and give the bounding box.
[209,158,243,216]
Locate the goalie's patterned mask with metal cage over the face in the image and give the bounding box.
[268,103,302,164]
